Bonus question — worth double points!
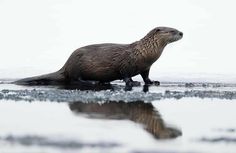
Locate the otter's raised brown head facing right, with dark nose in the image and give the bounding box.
[146,27,183,44]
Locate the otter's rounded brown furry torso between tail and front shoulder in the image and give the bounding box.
[64,44,131,82]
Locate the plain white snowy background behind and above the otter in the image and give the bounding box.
[0,0,236,82]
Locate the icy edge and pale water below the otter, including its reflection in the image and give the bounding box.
[0,80,236,153]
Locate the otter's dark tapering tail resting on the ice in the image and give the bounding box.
[14,71,65,85]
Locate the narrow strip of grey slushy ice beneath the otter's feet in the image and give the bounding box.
[0,82,236,102]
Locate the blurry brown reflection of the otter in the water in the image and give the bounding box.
[69,101,182,139]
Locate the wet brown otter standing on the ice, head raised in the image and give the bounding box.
[15,27,183,86]
